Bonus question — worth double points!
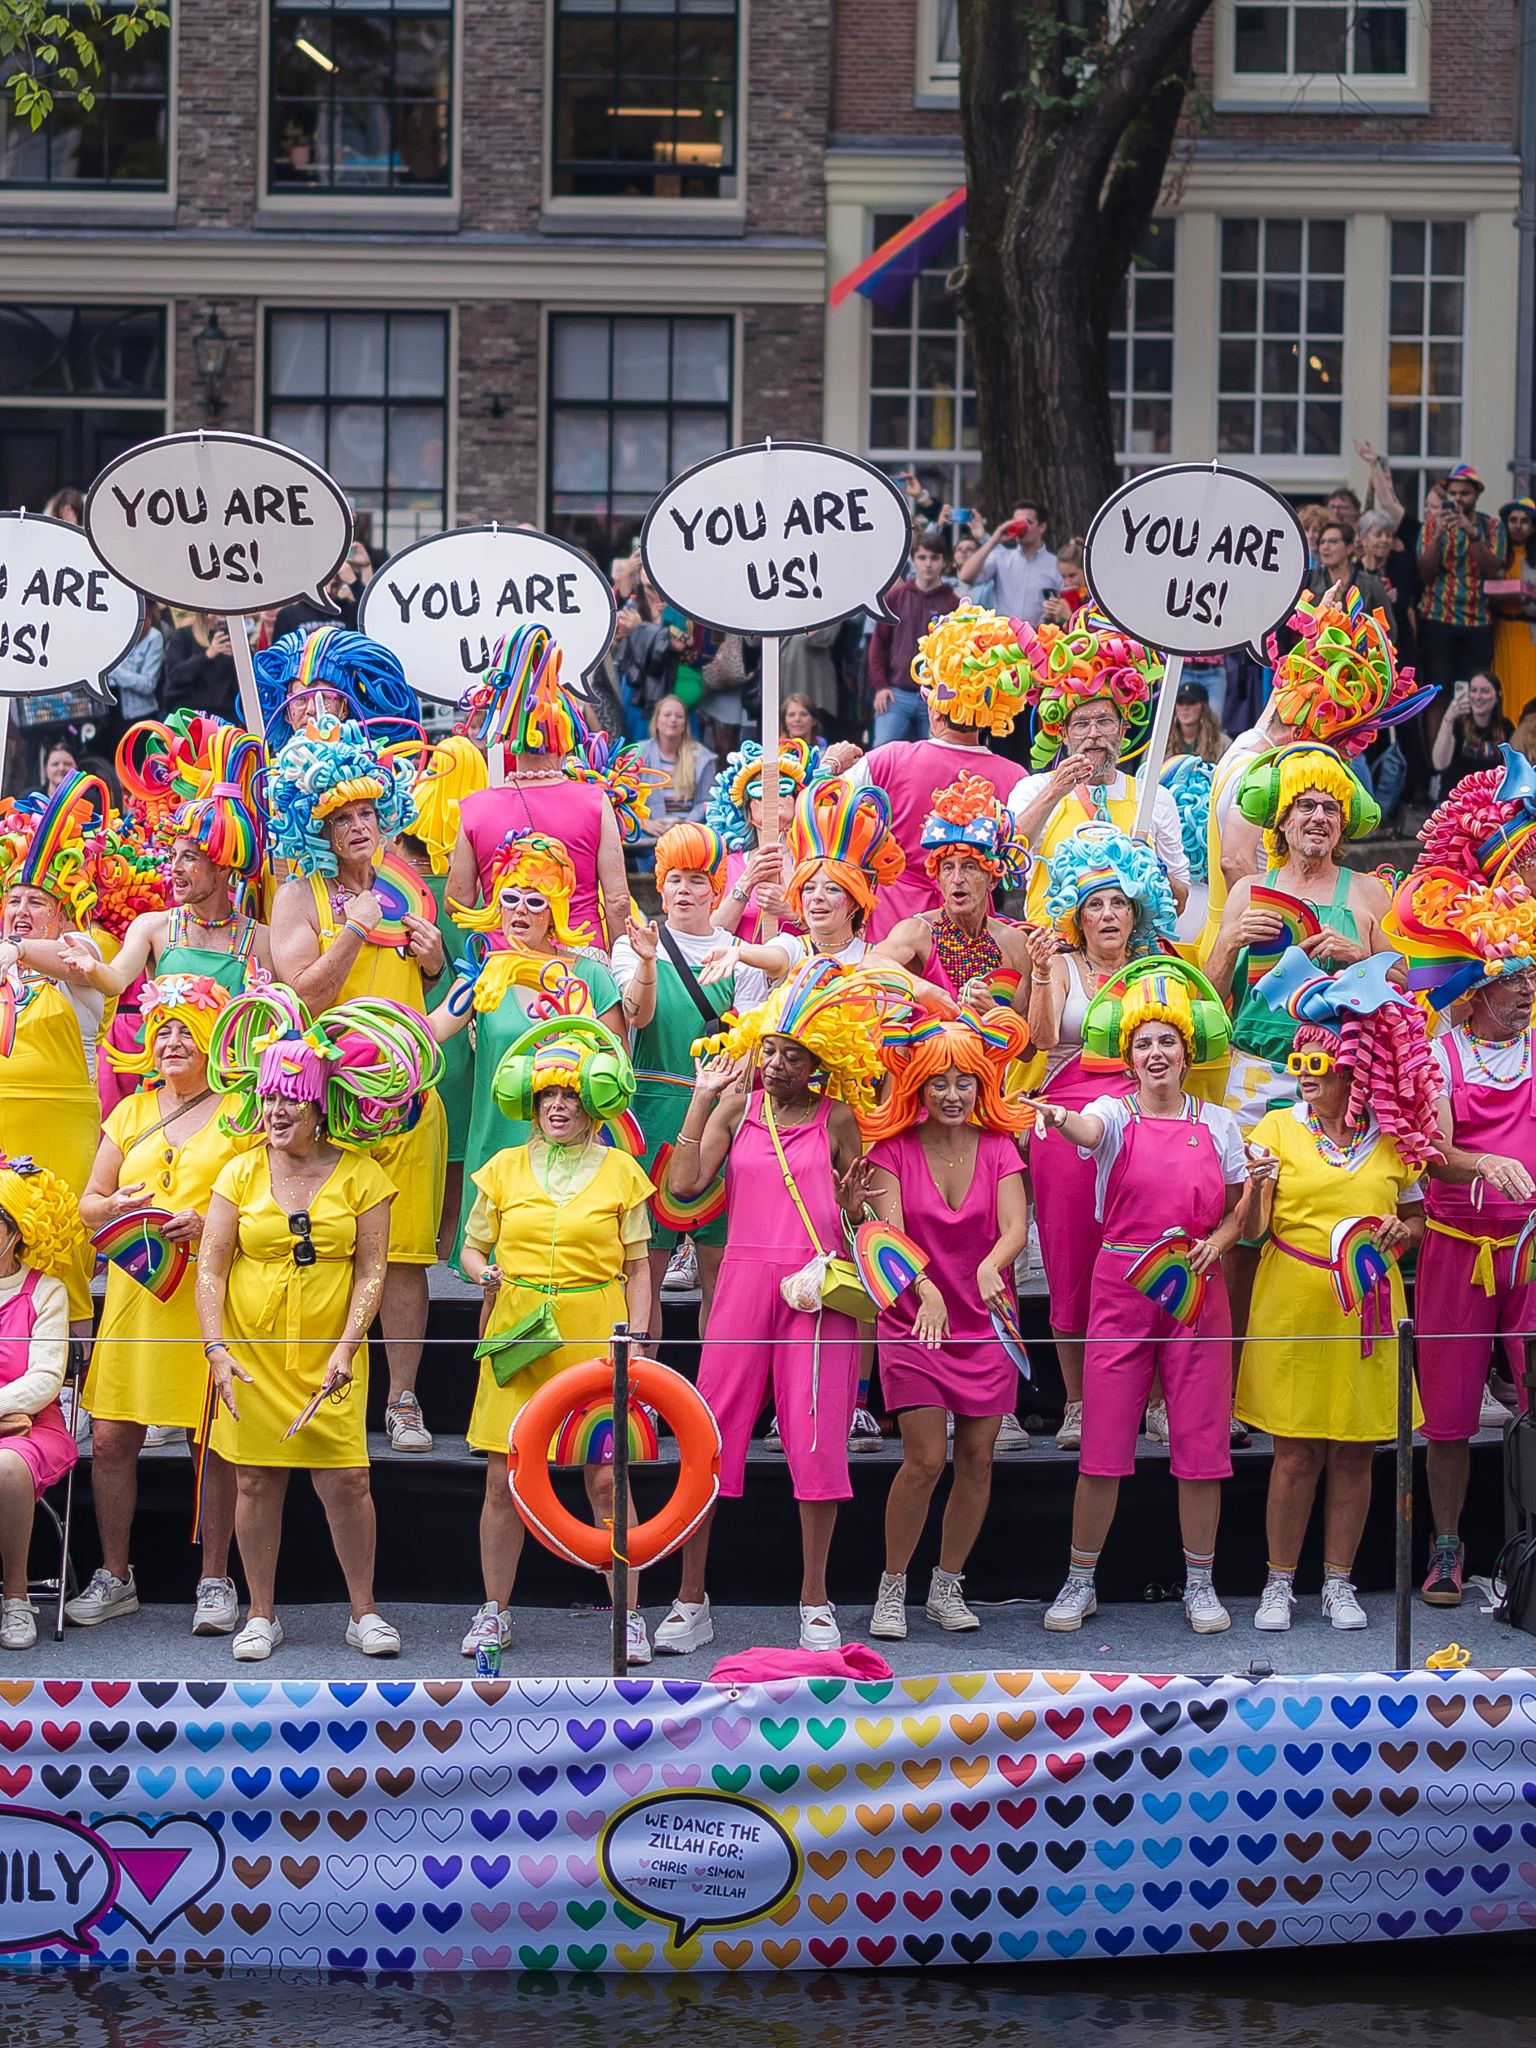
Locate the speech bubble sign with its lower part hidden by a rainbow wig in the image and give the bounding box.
[356,524,616,705]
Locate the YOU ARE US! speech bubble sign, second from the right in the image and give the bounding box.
[641,440,911,635]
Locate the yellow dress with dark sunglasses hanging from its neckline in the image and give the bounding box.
[211,1145,395,1470]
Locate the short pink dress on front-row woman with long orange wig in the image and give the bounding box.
[868,1126,1024,1415]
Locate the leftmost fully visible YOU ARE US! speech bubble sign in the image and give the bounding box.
[86,432,352,616]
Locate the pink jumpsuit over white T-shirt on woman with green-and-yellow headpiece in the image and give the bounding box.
[1077,1100,1233,1479]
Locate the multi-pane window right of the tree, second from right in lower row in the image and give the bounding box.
[1217,219,1343,455]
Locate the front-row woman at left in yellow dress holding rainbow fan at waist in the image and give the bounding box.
[63,975,250,1636]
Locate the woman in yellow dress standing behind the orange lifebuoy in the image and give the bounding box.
[461,1018,653,1663]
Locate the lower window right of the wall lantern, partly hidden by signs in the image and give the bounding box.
[266,313,449,553]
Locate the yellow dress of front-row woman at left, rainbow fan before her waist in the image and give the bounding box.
[84,1090,258,1432]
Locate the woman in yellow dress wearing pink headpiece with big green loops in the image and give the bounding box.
[197,987,440,1663]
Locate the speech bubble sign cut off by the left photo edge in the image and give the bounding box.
[0,512,143,700]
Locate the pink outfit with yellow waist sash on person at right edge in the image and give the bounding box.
[1413,1032,1536,1444]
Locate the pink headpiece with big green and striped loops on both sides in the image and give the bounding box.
[209,981,442,1151]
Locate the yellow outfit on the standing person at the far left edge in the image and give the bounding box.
[0,977,100,1323]
